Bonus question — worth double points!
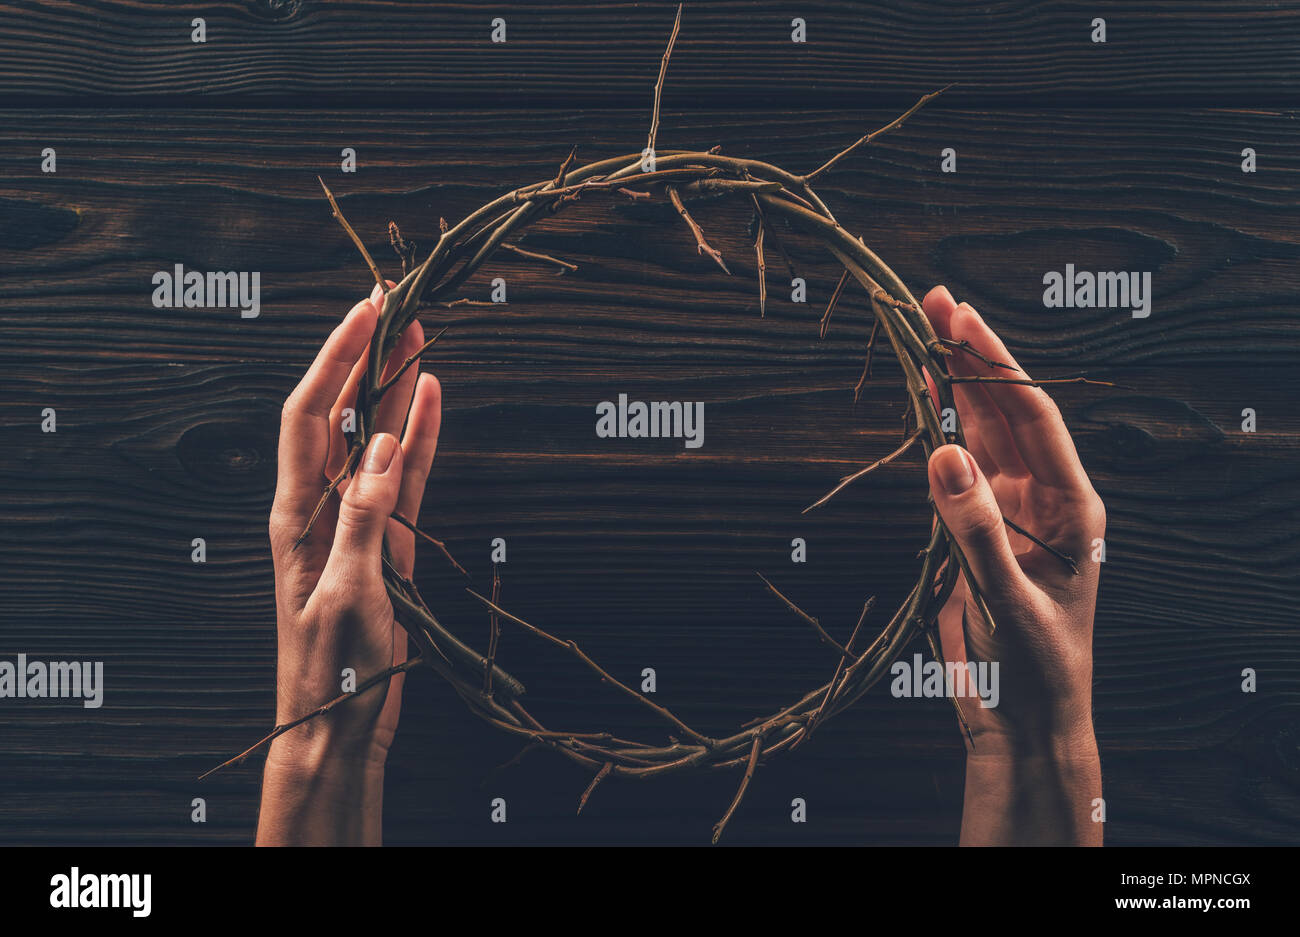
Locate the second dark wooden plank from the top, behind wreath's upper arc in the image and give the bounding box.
[0,101,1300,368]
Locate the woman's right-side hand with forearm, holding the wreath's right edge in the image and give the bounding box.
[923,286,1106,845]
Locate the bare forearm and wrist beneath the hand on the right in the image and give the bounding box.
[961,726,1104,846]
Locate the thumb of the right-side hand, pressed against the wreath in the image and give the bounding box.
[930,446,1028,603]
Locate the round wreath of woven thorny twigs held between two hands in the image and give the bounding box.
[209,8,1100,843]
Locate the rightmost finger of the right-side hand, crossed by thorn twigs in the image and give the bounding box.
[952,303,1091,489]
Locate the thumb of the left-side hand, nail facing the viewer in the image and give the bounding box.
[325,433,402,580]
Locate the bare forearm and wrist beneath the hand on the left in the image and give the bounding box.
[257,733,384,846]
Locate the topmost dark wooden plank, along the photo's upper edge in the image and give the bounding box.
[0,0,1300,110]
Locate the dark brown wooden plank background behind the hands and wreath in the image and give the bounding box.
[0,0,1300,845]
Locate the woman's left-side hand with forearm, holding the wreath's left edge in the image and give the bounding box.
[257,287,442,845]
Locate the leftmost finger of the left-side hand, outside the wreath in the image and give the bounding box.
[274,302,376,525]
